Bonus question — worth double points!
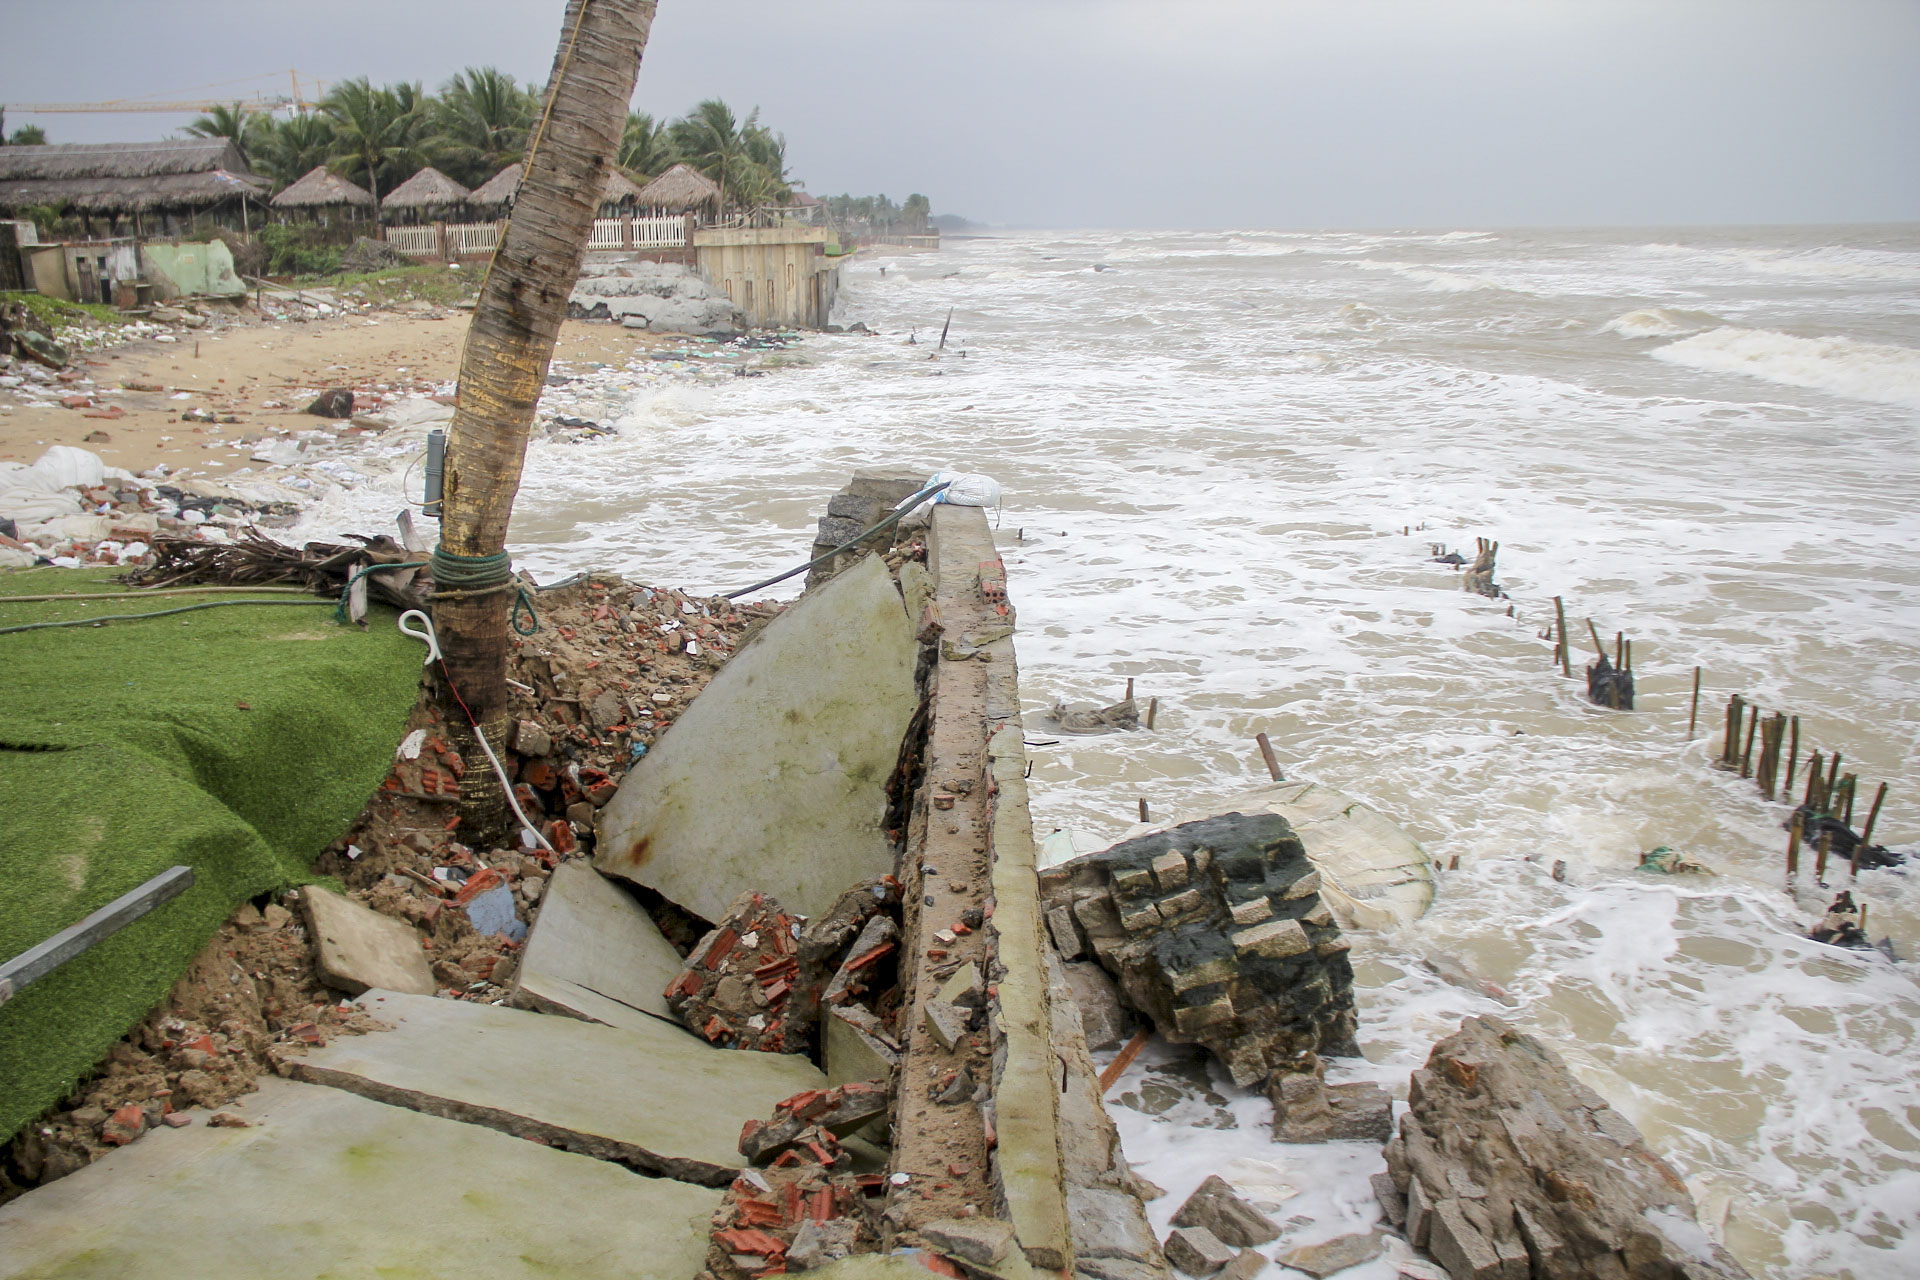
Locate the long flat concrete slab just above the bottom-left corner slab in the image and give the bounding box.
[288,990,826,1186]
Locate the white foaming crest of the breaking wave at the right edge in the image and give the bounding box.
[1653,328,1920,407]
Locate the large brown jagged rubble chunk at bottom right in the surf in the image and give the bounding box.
[1377,1017,1747,1280]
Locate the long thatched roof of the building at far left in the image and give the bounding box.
[0,138,267,213]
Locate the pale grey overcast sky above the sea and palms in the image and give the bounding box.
[0,0,1920,226]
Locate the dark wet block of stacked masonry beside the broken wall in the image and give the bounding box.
[1041,814,1359,1086]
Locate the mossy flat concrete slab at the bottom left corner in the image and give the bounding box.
[0,1077,720,1280]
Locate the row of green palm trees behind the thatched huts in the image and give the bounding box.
[186,67,793,207]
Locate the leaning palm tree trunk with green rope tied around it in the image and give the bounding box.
[434,0,657,848]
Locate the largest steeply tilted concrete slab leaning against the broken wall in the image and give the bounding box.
[595,557,918,919]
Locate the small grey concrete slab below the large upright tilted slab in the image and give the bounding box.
[507,862,680,1027]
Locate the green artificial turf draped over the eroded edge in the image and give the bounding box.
[0,570,422,1140]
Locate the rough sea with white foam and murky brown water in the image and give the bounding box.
[309,228,1920,1280]
